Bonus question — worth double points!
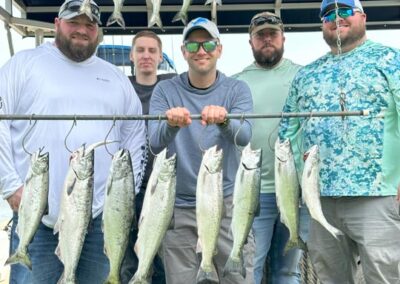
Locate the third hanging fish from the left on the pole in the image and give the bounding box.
[102,149,135,284]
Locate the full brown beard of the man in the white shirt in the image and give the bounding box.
[55,31,98,62]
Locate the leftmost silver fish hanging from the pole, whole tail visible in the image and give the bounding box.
[5,149,49,270]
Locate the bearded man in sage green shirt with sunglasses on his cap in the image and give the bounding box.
[234,12,309,284]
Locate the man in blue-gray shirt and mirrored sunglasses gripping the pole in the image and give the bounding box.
[149,18,254,284]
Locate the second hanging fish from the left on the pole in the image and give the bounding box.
[54,141,108,283]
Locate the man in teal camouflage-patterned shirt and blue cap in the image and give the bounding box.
[279,0,400,284]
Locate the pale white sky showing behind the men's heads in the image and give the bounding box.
[0,0,400,76]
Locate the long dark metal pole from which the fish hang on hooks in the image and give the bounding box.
[0,110,369,120]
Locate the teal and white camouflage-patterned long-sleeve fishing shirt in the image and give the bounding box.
[279,40,400,196]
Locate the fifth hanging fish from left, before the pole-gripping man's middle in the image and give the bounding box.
[196,146,224,283]
